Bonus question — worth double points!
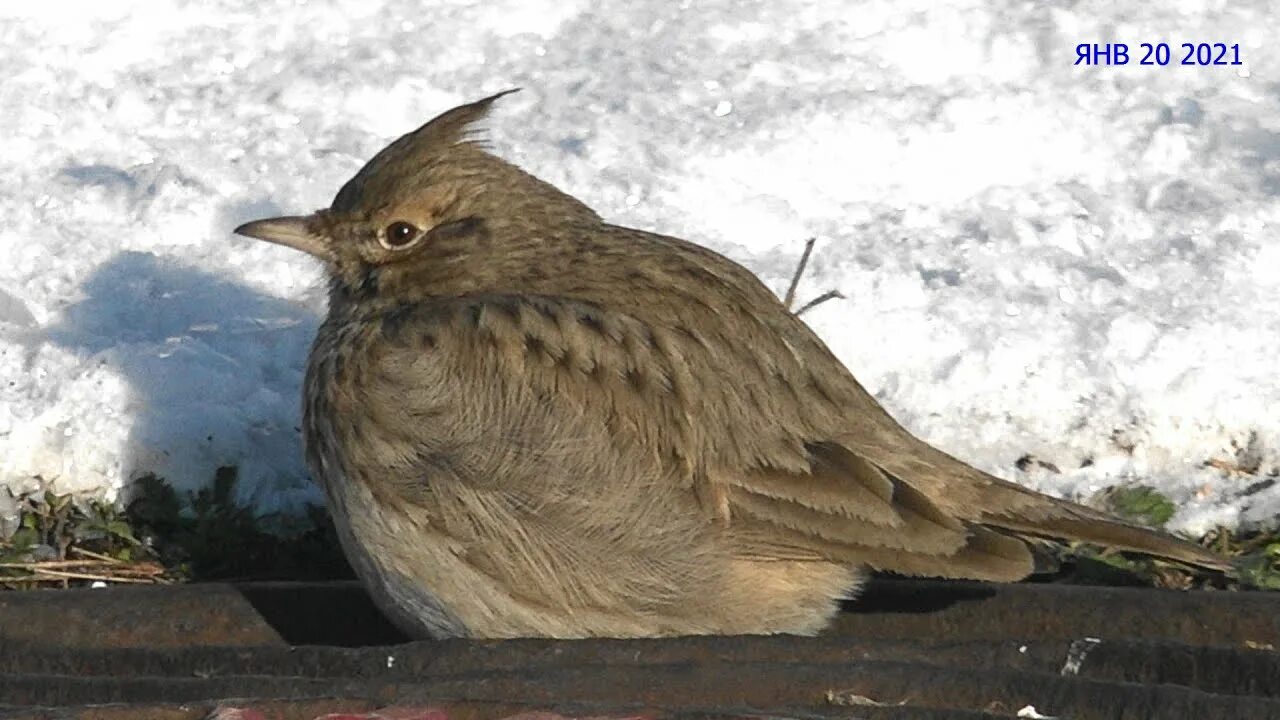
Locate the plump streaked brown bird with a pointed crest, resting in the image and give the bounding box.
[234,90,1226,638]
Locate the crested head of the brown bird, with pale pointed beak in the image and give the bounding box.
[236,90,599,302]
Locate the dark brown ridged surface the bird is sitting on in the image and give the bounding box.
[0,580,1280,720]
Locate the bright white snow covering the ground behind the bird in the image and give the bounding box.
[0,0,1280,532]
